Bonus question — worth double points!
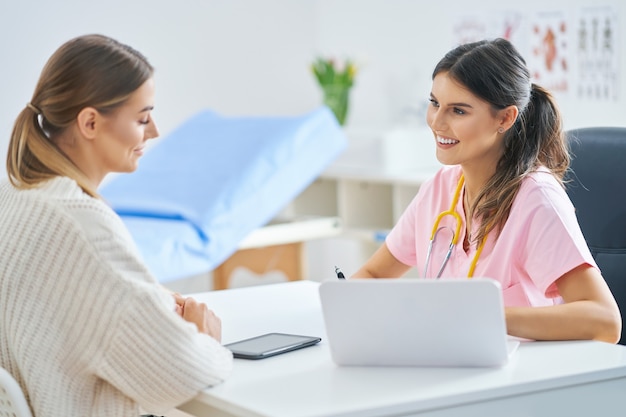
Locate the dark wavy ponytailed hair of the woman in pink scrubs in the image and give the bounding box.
[432,38,570,242]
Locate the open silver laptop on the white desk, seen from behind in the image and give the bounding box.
[319,278,519,367]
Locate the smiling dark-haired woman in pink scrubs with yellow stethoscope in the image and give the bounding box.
[352,39,621,343]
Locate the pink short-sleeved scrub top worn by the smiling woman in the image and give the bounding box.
[386,166,597,307]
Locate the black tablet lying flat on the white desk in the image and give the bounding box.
[224,333,322,359]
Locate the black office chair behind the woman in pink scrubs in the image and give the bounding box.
[566,127,626,345]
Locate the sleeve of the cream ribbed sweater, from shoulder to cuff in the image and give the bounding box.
[64,196,233,413]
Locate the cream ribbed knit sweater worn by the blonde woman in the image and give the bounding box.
[0,177,233,417]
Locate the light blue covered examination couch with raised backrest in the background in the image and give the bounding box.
[100,107,347,282]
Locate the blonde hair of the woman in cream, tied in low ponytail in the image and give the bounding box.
[6,34,154,197]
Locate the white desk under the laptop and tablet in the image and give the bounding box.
[180,281,626,417]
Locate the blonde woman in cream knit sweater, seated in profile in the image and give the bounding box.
[0,35,232,417]
